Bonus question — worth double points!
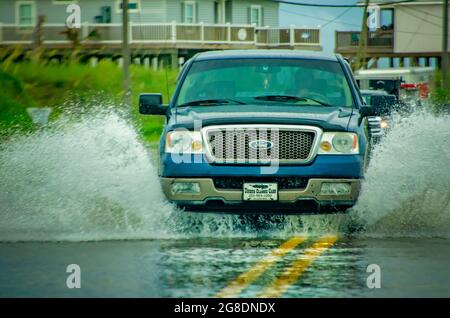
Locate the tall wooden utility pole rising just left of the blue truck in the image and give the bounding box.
[122,0,132,106]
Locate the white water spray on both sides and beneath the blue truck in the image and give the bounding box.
[0,105,450,241]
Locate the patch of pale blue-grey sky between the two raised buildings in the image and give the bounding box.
[280,0,362,53]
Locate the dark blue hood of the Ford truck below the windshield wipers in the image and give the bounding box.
[167,104,358,131]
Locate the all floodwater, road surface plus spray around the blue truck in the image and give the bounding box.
[0,109,450,297]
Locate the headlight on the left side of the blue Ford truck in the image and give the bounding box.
[165,130,203,154]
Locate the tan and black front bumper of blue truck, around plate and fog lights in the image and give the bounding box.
[161,178,360,213]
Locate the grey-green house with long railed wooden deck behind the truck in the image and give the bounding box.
[0,0,321,64]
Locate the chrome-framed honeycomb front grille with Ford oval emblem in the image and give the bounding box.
[205,126,320,164]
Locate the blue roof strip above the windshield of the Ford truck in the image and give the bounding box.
[195,50,337,61]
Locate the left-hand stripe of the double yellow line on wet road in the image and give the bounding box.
[215,236,307,298]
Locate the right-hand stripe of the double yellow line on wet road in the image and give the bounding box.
[259,236,338,298]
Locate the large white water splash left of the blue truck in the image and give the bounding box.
[0,107,173,240]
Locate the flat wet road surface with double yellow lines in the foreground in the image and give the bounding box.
[0,236,450,297]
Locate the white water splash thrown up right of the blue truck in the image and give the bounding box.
[351,111,450,237]
